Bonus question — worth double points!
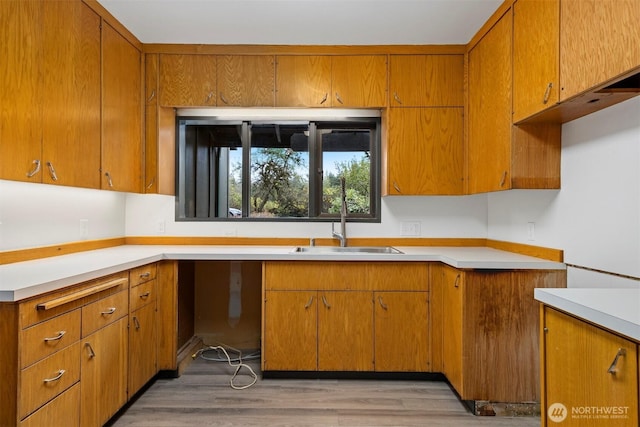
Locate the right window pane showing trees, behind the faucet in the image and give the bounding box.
[319,129,372,216]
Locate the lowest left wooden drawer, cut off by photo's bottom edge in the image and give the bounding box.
[20,383,80,427]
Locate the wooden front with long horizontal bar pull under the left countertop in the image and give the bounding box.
[19,271,129,329]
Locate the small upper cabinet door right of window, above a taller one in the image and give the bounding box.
[389,55,464,107]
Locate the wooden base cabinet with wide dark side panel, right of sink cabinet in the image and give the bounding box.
[430,264,566,412]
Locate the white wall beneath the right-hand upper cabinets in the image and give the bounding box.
[488,98,640,286]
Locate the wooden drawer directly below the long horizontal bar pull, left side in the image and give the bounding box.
[20,309,80,368]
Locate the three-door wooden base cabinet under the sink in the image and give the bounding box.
[262,261,429,372]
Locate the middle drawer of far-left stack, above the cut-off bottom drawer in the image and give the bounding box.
[18,342,80,419]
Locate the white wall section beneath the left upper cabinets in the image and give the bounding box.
[0,180,125,250]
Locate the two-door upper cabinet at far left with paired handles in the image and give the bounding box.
[0,1,100,188]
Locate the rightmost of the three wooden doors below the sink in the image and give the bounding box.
[374,292,429,372]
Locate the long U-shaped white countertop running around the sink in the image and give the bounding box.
[0,245,566,302]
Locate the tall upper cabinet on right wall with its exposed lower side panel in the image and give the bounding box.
[467,9,561,194]
